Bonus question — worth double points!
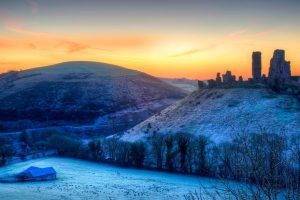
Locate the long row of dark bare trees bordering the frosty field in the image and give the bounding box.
[0,131,300,200]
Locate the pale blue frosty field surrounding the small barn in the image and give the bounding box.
[0,158,221,200]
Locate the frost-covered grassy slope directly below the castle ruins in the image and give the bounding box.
[122,88,300,142]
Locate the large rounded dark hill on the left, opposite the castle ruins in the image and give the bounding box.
[0,62,186,133]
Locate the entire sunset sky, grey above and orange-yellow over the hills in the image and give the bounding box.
[0,0,300,79]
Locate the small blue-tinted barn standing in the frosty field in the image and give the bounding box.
[17,167,56,181]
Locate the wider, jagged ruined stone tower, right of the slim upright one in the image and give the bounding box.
[268,49,291,85]
